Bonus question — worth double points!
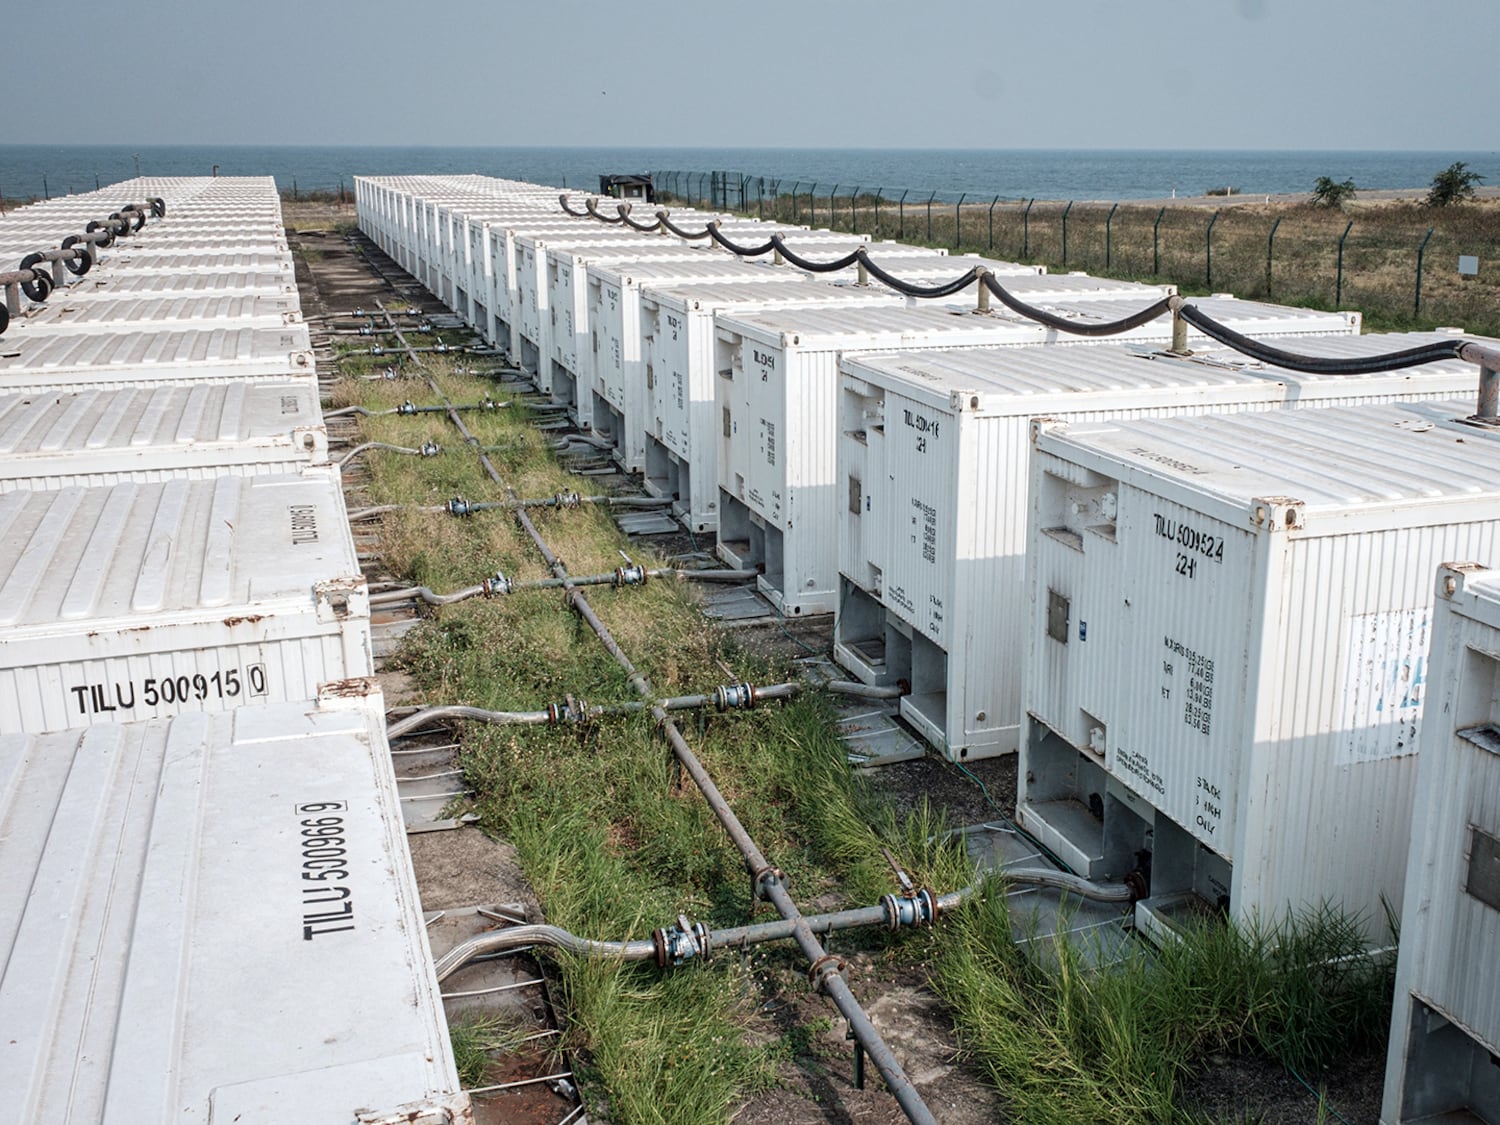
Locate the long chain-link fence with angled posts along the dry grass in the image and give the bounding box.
[654,171,1500,335]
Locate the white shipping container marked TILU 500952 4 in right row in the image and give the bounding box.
[1017,398,1500,941]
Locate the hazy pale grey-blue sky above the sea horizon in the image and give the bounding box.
[0,0,1500,150]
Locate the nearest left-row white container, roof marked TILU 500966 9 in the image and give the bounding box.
[0,693,470,1125]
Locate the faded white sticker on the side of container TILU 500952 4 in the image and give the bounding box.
[1338,609,1431,765]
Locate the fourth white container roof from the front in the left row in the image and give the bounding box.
[0,324,315,392]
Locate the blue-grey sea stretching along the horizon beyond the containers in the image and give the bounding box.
[0,144,1500,203]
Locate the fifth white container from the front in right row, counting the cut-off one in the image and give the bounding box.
[641,283,903,537]
